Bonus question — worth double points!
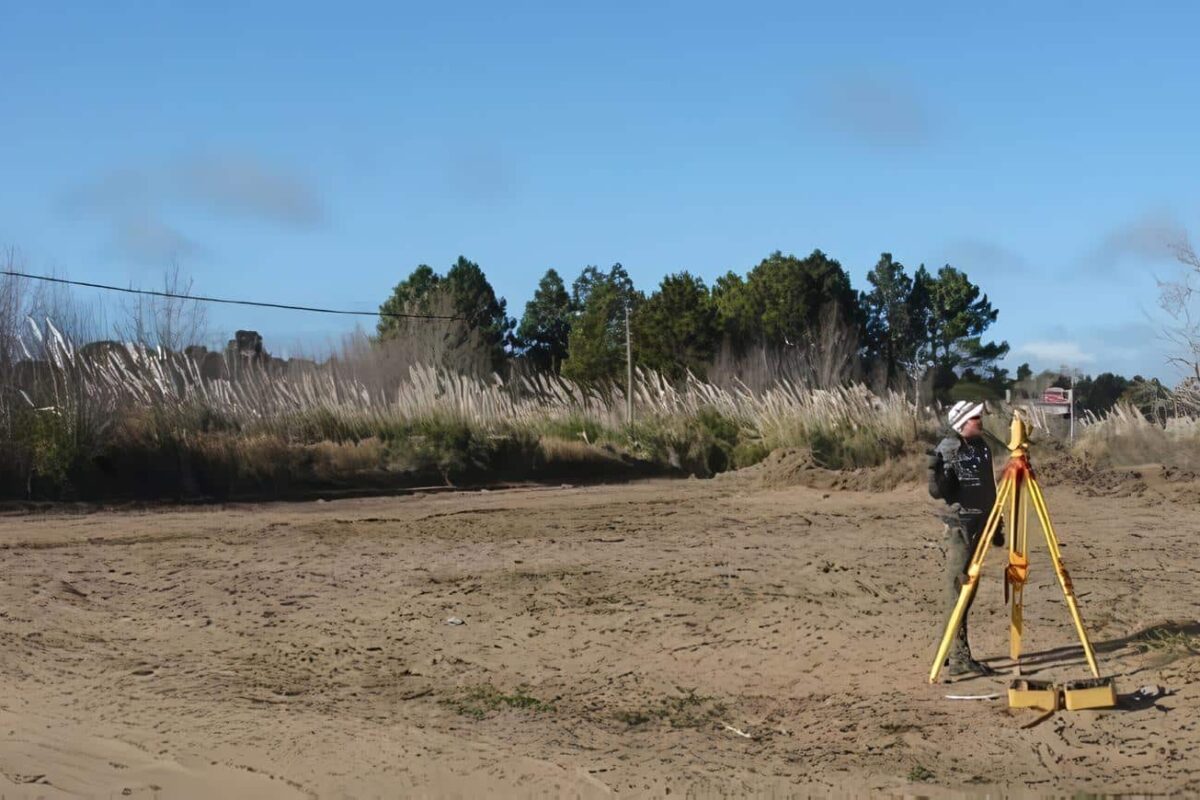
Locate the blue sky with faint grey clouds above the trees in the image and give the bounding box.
[0,2,1200,378]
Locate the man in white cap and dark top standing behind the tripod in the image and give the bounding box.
[929,401,1004,676]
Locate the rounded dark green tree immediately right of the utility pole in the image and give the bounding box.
[632,272,720,378]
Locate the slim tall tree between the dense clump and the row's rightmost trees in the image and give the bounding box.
[862,253,917,383]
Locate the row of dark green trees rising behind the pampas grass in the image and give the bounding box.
[377,249,1128,410]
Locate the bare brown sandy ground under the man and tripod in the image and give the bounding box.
[0,473,1200,798]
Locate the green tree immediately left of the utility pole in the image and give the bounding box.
[562,264,641,383]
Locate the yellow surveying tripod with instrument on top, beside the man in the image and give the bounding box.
[929,411,1100,684]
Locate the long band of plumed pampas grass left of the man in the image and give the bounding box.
[0,320,934,497]
